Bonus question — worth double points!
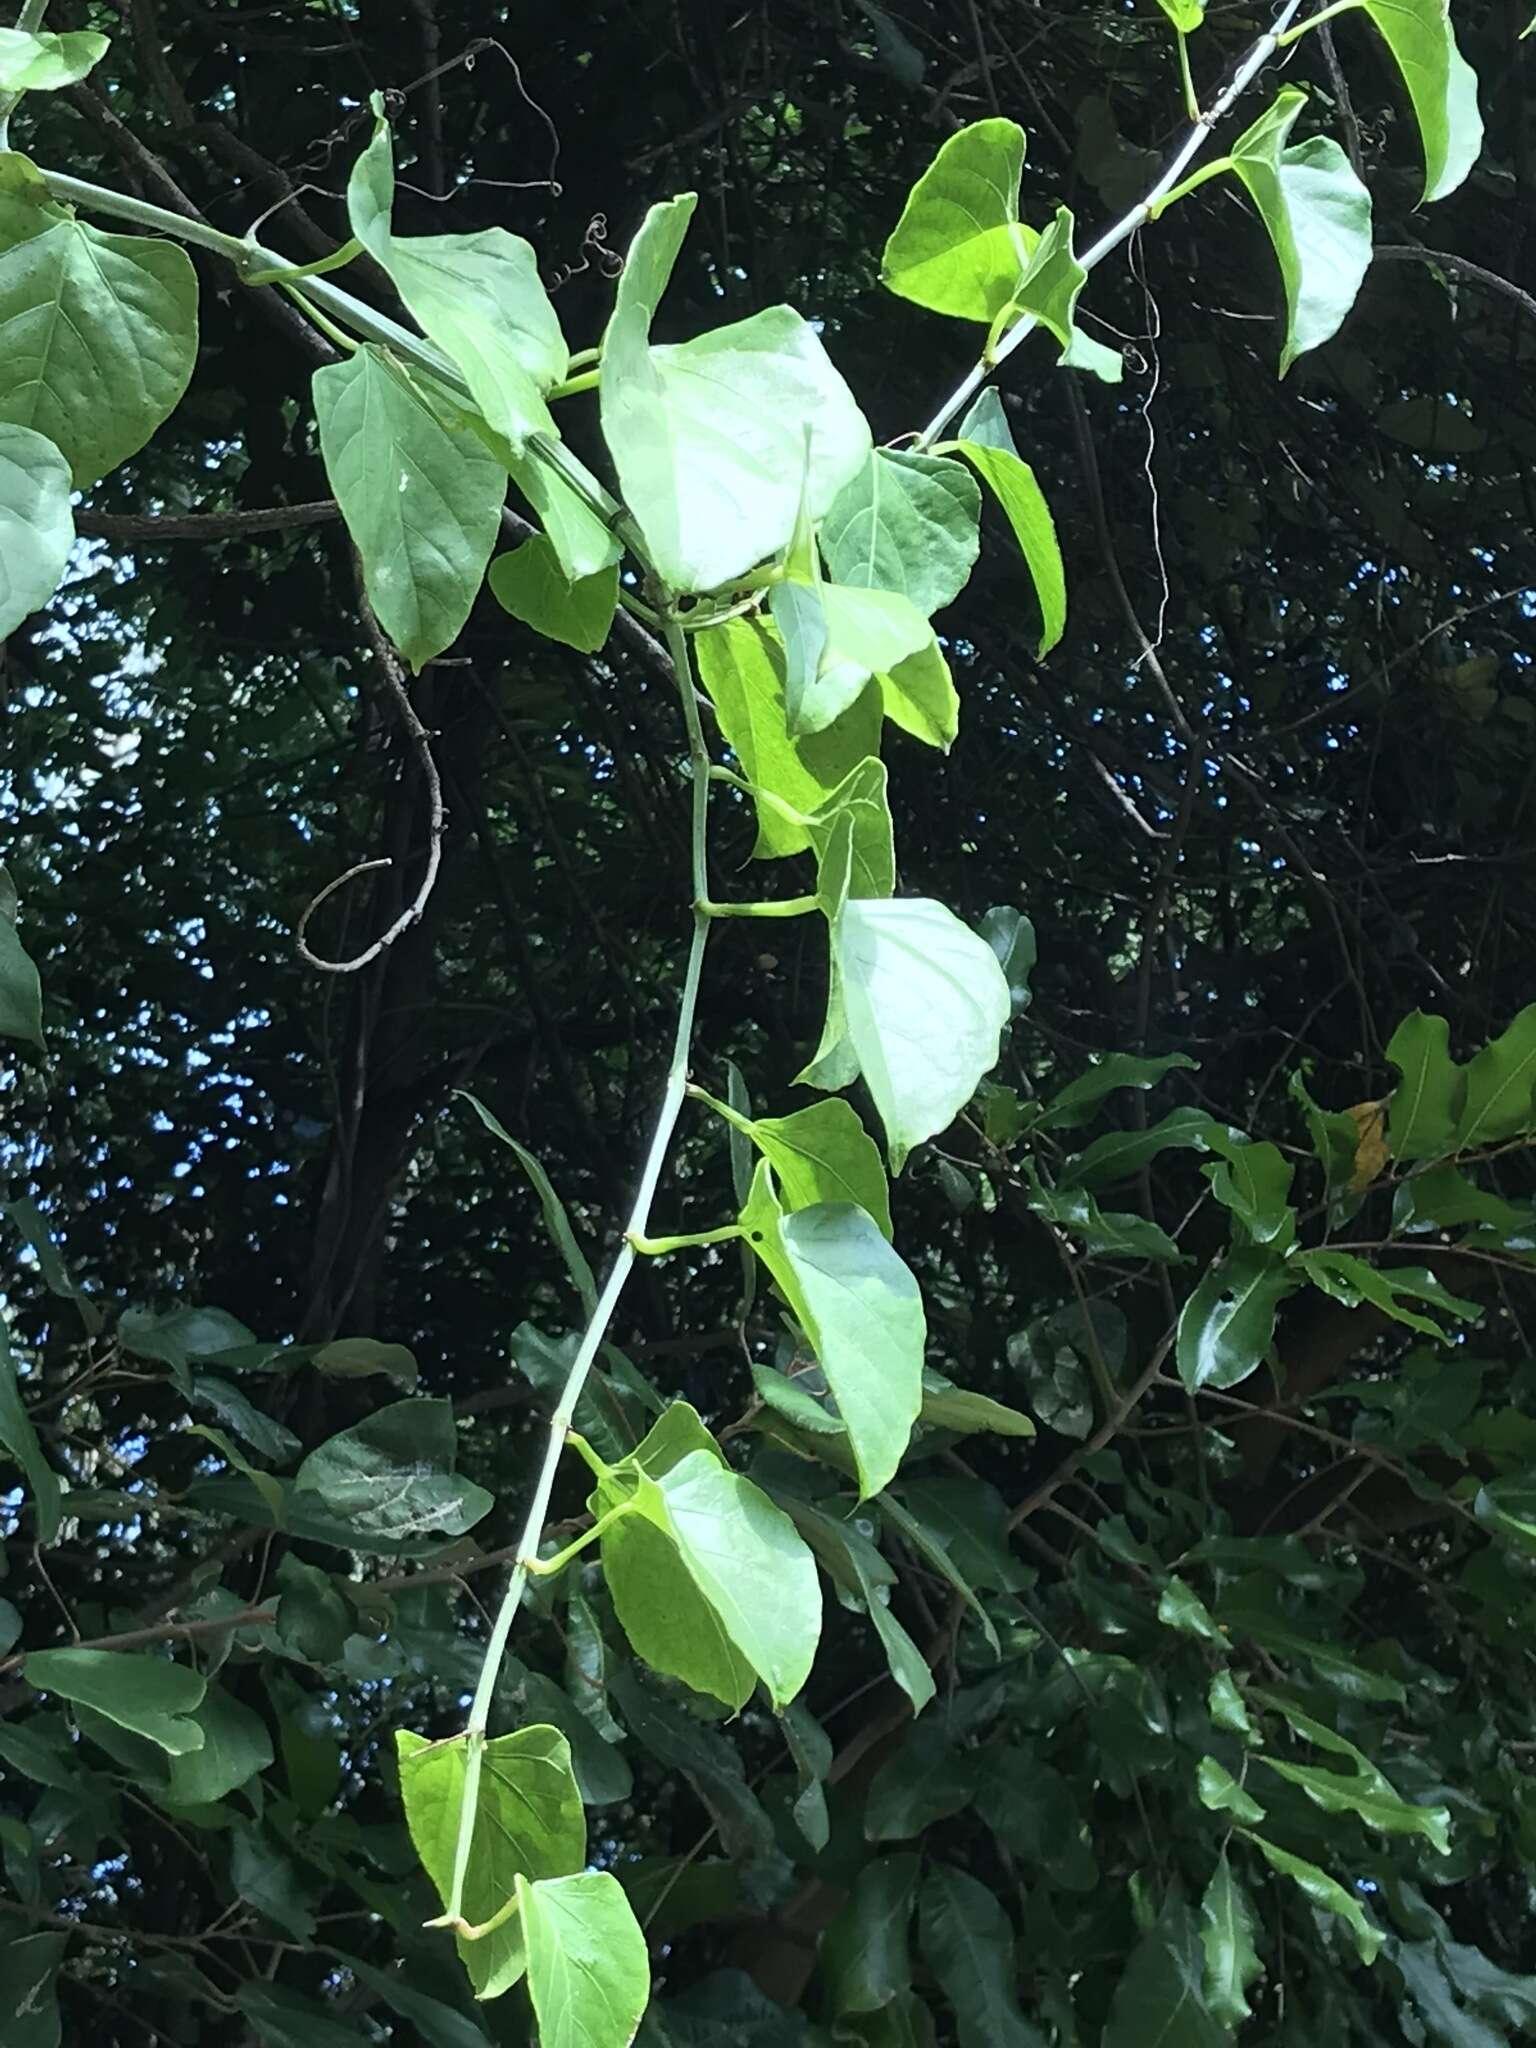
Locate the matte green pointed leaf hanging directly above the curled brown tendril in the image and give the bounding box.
[313,344,506,670]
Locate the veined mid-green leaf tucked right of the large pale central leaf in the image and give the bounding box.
[821,449,981,618]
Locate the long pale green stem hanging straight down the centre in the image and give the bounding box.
[432,606,711,1927]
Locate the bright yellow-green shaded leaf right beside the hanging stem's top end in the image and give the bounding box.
[694,618,883,860]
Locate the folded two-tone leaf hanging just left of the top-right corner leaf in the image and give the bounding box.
[1231,86,1370,377]
